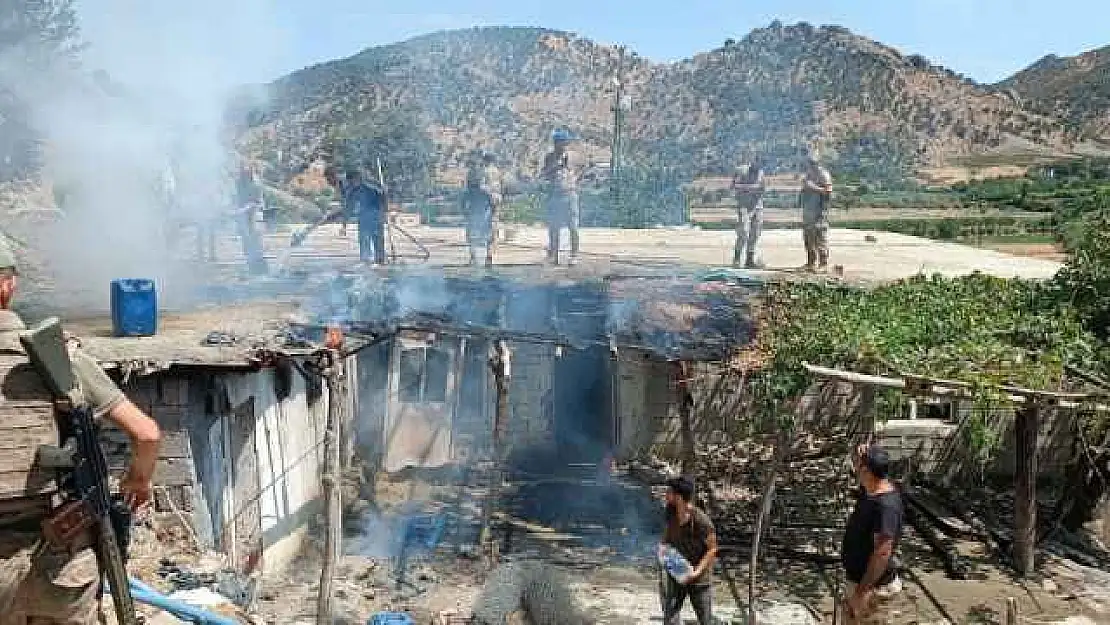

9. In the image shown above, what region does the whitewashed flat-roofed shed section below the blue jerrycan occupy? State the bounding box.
[67,304,356,572]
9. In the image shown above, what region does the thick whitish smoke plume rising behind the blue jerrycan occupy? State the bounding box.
[0,0,282,311]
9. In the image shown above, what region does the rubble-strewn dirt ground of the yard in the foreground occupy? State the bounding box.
[234,470,1110,625]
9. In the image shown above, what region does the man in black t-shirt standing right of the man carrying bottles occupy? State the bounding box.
[840,445,904,623]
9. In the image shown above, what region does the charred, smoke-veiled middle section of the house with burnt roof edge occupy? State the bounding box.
[308,274,756,472]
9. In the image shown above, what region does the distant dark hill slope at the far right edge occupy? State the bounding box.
[997,46,1110,142]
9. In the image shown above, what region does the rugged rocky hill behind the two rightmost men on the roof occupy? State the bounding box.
[640,24,1083,164]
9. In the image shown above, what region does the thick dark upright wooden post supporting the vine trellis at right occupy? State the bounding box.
[1013,402,1040,576]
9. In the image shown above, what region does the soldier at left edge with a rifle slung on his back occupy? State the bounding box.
[0,242,161,625]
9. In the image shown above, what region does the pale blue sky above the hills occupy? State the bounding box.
[78,0,1110,82]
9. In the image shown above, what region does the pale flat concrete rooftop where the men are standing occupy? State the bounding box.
[254,225,1060,283]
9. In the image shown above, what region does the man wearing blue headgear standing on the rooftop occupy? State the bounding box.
[539,128,581,265]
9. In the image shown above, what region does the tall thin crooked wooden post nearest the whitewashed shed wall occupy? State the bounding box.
[316,350,345,625]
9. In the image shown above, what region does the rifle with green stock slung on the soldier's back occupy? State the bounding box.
[19,317,137,625]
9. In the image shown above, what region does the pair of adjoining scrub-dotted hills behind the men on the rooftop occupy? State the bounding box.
[243,22,1092,193]
